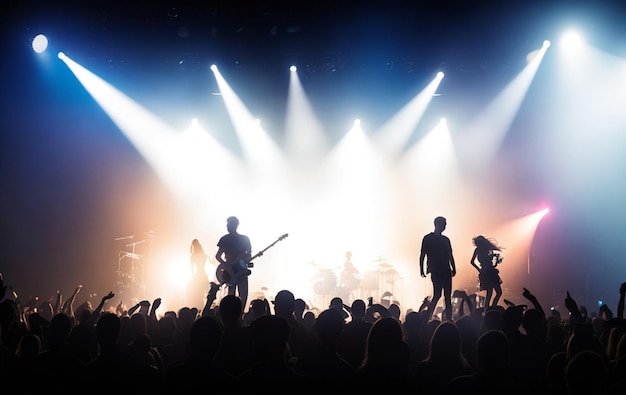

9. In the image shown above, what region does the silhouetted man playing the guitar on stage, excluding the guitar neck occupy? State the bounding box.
[215,217,252,306]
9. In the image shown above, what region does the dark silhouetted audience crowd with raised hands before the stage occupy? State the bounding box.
[0,277,626,395]
